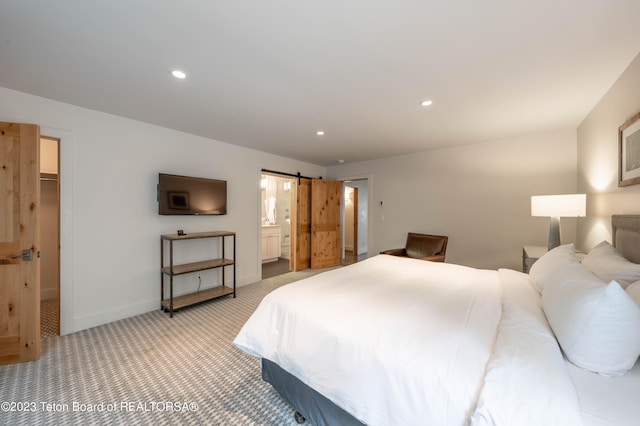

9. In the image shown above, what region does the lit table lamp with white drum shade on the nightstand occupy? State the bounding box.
[531,194,587,250]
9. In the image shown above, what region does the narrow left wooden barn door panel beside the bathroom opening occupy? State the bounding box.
[292,178,311,271]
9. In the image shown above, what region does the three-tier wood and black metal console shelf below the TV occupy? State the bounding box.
[160,231,236,317]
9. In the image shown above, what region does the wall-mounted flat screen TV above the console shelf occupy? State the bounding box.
[158,173,227,215]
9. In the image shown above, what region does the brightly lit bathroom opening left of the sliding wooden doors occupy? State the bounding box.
[260,172,296,279]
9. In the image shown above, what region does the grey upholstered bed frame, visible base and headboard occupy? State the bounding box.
[262,215,640,426]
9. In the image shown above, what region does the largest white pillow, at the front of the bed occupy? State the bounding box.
[542,277,640,376]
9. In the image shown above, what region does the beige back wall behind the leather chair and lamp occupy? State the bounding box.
[328,129,577,269]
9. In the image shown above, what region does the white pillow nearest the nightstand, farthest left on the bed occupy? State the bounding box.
[529,244,580,293]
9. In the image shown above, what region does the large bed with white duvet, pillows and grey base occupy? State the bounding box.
[234,216,640,426]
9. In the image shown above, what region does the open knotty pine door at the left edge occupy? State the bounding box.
[0,122,40,364]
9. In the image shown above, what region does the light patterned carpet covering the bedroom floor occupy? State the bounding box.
[0,271,330,425]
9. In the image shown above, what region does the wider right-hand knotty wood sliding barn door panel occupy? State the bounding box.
[311,179,342,269]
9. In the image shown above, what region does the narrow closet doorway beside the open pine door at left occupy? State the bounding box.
[40,136,60,339]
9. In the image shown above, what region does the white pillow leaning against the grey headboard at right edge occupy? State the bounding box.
[582,241,640,288]
